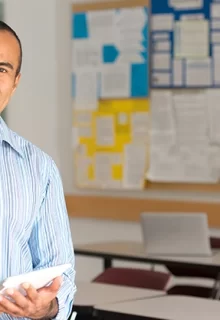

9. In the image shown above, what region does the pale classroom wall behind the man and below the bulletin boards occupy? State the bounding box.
[5,0,220,280]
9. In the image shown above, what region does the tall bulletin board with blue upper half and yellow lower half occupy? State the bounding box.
[72,0,149,189]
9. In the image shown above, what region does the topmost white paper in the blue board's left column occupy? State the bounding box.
[152,14,174,31]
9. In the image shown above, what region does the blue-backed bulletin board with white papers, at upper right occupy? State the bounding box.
[151,0,220,88]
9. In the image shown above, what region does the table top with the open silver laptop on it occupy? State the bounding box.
[75,241,220,268]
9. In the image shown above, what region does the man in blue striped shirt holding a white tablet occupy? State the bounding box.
[0,21,76,320]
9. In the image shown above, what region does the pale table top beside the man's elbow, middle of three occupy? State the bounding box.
[74,282,165,307]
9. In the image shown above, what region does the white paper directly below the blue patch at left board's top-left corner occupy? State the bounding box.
[72,39,101,72]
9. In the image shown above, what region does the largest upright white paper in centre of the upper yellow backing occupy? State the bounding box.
[96,116,115,147]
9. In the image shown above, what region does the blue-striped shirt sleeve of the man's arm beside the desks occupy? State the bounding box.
[29,161,76,320]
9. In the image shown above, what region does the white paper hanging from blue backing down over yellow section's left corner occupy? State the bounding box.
[73,69,98,111]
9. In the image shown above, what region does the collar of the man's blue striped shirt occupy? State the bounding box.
[0,117,24,157]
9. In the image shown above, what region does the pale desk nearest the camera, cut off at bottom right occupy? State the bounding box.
[95,296,220,320]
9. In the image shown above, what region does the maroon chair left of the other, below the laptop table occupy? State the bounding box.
[93,267,170,291]
